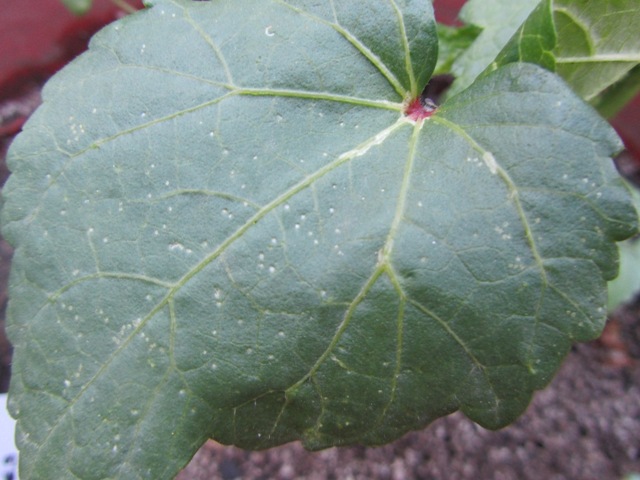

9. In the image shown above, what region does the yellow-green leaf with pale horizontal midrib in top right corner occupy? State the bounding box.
[554,0,640,100]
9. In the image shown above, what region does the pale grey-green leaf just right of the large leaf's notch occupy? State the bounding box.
[447,0,540,96]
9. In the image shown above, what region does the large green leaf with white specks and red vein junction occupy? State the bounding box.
[2,0,636,479]
